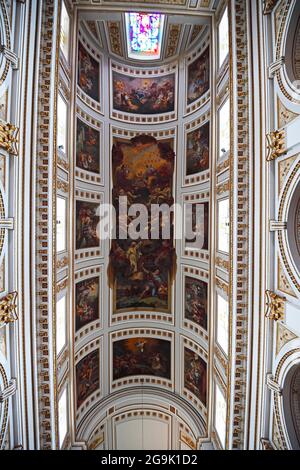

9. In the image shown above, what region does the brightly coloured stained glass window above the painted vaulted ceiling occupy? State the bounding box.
[125,13,164,60]
